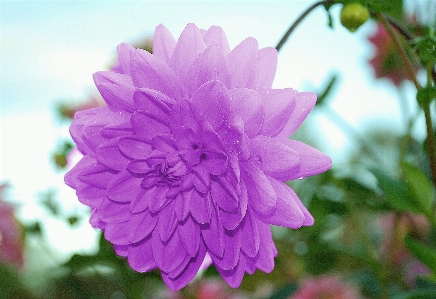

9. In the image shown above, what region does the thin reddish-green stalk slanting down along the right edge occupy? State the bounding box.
[377,13,436,187]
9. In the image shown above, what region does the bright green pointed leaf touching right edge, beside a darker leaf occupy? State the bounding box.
[403,163,434,215]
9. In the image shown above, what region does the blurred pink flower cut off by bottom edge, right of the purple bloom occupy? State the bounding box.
[289,275,361,299]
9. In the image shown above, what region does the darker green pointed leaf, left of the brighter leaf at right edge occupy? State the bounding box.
[371,169,422,213]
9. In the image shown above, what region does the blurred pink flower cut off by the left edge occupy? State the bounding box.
[0,184,24,268]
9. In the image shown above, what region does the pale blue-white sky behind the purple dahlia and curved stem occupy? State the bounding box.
[0,0,420,260]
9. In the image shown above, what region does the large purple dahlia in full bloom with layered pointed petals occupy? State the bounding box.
[65,24,331,290]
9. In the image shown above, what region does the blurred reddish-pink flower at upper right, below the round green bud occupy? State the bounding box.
[368,24,418,86]
